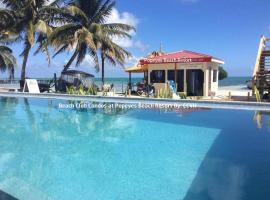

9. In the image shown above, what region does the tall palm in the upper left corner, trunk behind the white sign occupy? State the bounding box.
[0,0,60,80]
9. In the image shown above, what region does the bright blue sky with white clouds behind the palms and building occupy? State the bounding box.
[0,0,270,77]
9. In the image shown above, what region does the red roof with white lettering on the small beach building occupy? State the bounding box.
[140,50,223,64]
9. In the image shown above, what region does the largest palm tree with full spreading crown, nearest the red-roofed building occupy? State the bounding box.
[50,0,134,82]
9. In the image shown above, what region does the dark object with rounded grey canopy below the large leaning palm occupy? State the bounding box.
[56,70,95,92]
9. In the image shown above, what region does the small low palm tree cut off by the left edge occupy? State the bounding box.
[0,39,16,80]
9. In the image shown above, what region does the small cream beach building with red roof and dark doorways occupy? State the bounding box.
[125,50,224,96]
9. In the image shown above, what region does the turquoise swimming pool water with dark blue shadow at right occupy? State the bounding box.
[0,98,270,200]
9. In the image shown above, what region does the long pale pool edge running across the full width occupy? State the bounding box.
[0,92,270,111]
